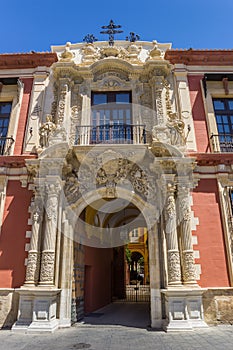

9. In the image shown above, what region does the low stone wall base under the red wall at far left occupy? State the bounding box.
[0,290,19,329]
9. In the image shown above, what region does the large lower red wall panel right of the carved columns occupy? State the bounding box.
[192,179,230,287]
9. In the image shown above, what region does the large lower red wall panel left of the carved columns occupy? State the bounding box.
[0,181,31,288]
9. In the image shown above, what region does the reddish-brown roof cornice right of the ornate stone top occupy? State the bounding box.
[165,49,233,66]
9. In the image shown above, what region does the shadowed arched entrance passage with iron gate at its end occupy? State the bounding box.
[70,195,161,327]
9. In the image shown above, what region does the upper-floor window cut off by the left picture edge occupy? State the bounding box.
[0,102,12,155]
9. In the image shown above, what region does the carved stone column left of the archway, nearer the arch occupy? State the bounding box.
[39,182,61,285]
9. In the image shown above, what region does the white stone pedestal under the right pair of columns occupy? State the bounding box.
[162,288,208,332]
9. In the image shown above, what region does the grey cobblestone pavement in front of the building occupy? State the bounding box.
[0,324,233,350]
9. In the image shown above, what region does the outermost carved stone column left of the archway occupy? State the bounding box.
[25,192,43,285]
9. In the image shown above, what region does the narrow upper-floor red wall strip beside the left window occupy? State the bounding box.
[14,78,33,155]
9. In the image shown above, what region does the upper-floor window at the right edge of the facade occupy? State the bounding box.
[213,98,233,152]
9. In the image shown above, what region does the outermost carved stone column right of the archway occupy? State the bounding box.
[179,187,197,284]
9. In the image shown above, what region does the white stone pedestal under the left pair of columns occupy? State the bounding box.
[12,287,60,333]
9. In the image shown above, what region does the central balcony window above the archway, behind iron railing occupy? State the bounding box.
[91,91,133,143]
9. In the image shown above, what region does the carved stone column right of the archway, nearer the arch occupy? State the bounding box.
[165,185,181,285]
